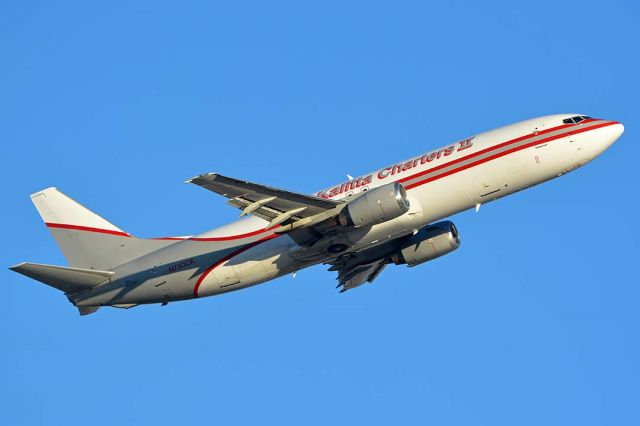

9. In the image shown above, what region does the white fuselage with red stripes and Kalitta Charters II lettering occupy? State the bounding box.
[72,114,623,305]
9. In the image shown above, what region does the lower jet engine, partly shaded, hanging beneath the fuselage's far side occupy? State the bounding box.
[391,220,460,266]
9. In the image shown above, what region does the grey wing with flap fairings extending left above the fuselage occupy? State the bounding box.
[187,173,346,244]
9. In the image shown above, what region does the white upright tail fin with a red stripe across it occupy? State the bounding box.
[31,188,174,272]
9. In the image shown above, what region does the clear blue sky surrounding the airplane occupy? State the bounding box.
[0,0,640,426]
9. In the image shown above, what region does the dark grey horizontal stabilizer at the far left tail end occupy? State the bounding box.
[10,262,113,294]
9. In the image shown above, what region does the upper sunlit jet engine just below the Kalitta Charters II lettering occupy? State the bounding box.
[338,182,409,228]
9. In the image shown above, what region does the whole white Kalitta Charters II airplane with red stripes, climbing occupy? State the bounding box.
[10,114,624,315]
